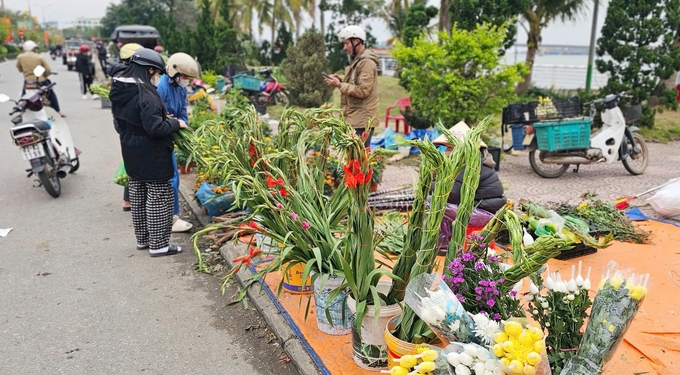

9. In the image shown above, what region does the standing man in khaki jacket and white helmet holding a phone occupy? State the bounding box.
[324,25,378,147]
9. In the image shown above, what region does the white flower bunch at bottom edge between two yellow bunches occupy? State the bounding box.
[441,342,503,375]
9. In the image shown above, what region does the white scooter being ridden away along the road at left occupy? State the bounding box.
[0,66,80,198]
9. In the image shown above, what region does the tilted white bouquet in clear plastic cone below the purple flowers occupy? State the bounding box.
[404,273,480,343]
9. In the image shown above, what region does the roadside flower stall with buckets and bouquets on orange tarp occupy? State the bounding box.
[177,103,680,375]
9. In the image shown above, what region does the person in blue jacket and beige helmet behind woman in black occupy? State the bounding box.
[156,52,198,232]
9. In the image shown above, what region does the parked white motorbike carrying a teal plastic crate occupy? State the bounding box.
[525,92,649,178]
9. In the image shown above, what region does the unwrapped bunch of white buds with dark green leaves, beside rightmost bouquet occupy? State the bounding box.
[526,262,592,374]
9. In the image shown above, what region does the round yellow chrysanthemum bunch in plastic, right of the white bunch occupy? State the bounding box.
[491,318,551,375]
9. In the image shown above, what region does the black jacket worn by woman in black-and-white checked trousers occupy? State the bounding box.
[109,77,179,181]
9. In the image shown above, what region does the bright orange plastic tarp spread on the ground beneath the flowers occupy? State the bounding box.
[254,221,680,375]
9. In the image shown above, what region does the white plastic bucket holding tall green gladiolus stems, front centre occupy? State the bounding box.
[347,280,401,371]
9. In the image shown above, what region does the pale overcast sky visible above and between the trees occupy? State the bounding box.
[4,0,608,45]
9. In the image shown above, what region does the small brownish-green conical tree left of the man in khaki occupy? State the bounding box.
[281,29,333,107]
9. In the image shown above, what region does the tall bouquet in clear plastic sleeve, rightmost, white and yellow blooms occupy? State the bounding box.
[561,261,649,375]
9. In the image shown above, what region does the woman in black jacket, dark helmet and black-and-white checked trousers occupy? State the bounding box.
[109,48,187,257]
